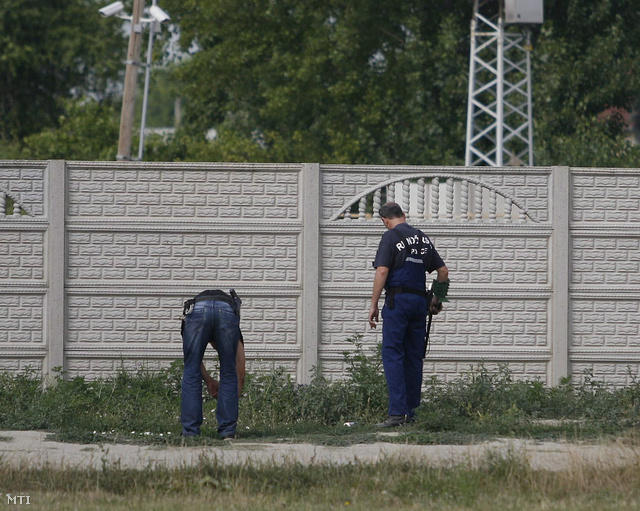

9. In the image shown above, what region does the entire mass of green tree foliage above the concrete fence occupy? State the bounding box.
[0,0,640,167]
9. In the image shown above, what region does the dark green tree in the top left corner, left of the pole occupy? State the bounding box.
[0,0,126,141]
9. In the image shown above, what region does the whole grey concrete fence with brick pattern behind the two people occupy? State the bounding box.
[0,160,640,385]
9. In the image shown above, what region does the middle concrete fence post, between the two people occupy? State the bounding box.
[299,163,320,383]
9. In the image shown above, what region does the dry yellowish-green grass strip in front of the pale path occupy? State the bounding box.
[0,453,640,511]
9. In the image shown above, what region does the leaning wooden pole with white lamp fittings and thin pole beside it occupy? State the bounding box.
[98,0,171,160]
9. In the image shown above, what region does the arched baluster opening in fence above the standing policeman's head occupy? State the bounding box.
[331,174,537,223]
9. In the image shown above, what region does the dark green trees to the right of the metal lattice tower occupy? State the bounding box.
[534,0,640,167]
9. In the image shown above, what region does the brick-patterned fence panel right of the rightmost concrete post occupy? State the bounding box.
[569,168,640,385]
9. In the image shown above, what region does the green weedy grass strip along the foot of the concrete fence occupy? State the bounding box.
[0,337,640,446]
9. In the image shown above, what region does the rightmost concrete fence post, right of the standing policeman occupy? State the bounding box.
[550,167,571,385]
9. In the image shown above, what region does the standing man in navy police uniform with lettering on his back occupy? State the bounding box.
[369,202,449,428]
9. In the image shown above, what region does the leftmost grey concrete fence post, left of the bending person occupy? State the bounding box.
[43,160,67,376]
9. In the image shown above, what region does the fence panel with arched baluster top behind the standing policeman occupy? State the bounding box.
[319,166,566,383]
